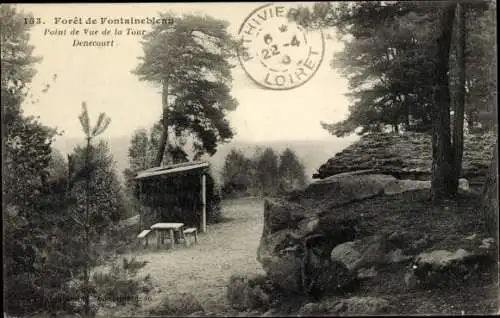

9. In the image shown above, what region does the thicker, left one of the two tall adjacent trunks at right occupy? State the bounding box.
[431,3,456,201]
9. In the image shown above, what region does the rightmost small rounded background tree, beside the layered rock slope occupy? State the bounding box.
[278,148,306,192]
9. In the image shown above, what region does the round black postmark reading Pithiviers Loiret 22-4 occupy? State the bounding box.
[238,4,325,90]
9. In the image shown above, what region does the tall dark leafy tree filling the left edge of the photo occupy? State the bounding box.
[0,5,66,315]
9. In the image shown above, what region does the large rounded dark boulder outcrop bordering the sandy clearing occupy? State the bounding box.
[257,171,446,294]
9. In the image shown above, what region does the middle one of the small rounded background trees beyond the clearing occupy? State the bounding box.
[256,147,278,195]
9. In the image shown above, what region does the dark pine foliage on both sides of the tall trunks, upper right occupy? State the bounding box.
[291,1,496,137]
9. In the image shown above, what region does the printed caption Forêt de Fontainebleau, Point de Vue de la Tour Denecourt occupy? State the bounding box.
[29,17,174,48]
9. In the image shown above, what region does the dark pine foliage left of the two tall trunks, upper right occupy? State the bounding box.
[292,2,433,137]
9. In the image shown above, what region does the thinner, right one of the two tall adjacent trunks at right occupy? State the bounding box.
[451,3,466,194]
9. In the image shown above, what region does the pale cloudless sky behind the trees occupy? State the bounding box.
[17,2,348,142]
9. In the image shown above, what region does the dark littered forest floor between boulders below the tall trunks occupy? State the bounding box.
[281,190,500,315]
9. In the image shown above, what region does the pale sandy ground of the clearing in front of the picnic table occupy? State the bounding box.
[102,198,264,316]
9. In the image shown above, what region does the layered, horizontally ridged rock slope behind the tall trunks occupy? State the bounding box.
[313,132,497,183]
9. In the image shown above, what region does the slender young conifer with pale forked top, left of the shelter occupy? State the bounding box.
[68,102,119,316]
